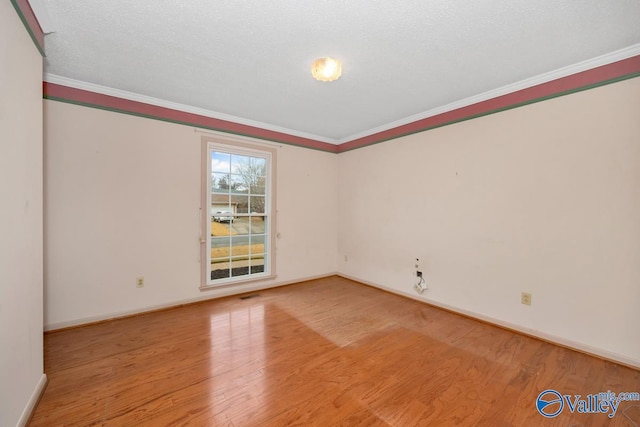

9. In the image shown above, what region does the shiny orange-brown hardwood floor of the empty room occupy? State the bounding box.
[30,277,640,427]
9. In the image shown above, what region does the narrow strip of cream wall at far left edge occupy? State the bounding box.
[0,2,46,426]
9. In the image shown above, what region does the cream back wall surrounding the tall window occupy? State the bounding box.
[45,101,337,329]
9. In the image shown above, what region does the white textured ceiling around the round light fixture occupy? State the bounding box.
[31,0,640,143]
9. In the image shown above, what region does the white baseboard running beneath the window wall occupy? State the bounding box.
[44,272,337,332]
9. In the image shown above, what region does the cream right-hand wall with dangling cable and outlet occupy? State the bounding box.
[338,78,640,366]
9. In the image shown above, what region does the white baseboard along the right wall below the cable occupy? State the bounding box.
[337,273,640,369]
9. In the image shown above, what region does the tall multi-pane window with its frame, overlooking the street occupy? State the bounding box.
[201,136,275,289]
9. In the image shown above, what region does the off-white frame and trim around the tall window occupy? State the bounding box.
[200,135,277,290]
